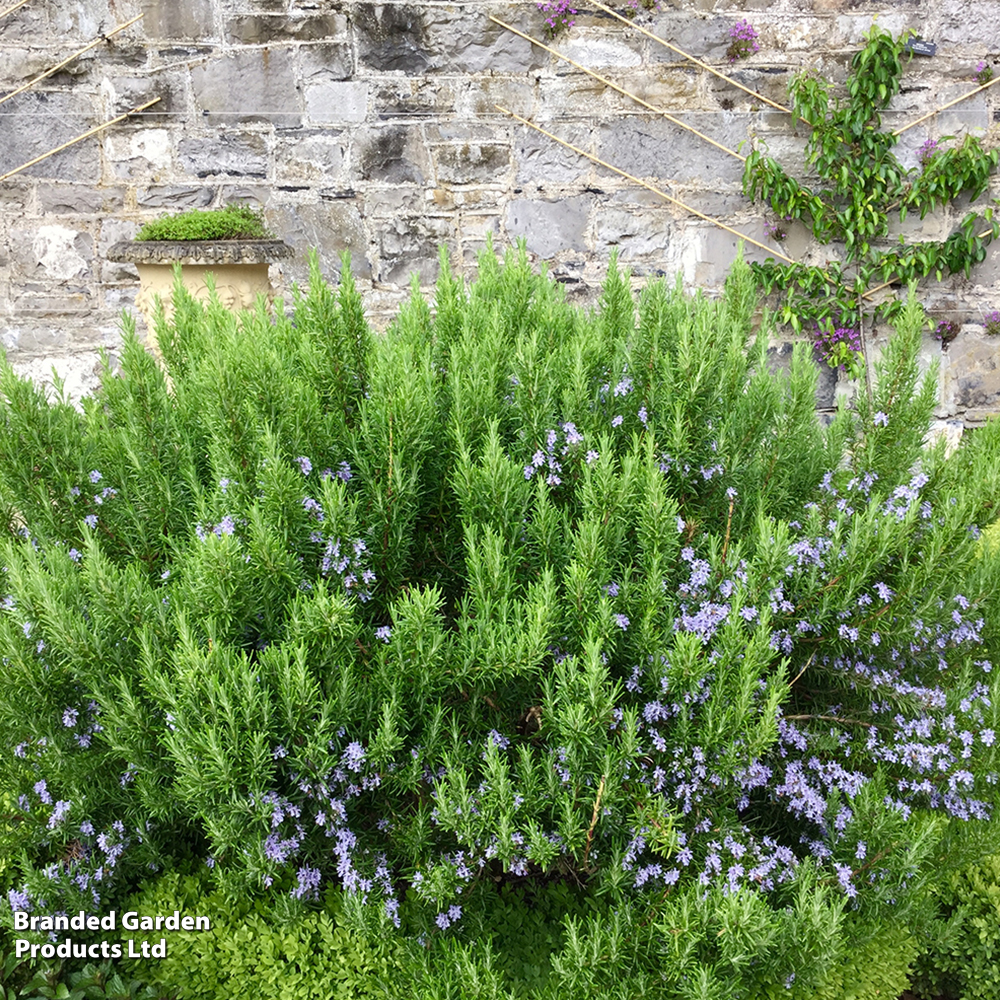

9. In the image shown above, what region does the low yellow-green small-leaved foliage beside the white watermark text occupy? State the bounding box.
[122,868,398,1000]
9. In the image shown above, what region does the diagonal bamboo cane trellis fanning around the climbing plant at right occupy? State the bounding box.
[490,12,1000,316]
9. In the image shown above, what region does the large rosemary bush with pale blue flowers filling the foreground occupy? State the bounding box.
[0,244,1000,1000]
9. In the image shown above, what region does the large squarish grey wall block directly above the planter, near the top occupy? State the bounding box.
[191,48,301,126]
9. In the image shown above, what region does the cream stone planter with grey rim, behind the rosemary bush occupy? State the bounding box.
[108,240,292,330]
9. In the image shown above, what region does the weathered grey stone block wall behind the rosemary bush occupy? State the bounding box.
[0,0,1000,423]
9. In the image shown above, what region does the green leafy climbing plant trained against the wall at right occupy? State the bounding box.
[743,25,1000,374]
